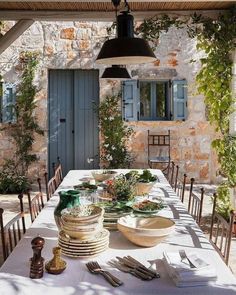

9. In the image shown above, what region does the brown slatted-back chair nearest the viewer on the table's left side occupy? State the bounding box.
[0,194,25,261]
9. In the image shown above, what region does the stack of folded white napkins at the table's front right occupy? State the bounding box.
[163,252,217,287]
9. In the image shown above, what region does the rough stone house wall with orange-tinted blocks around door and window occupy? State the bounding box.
[0,22,217,182]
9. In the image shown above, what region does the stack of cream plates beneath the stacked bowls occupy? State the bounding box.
[58,229,110,258]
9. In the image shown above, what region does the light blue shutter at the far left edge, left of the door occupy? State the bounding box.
[2,82,16,123]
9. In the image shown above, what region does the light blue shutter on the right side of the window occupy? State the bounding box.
[172,80,187,120]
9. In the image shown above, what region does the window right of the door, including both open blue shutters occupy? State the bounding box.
[122,80,187,121]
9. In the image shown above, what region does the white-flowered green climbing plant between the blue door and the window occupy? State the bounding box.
[98,95,133,169]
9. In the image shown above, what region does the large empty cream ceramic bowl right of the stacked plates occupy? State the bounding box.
[117,215,175,247]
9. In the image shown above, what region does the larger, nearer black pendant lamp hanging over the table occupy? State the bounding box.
[96,0,156,65]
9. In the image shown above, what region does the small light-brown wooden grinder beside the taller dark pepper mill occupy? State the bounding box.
[45,247,66,275]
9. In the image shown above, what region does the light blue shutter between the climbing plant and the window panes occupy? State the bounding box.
[122,80,139,121]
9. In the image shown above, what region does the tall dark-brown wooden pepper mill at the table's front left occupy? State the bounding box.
[30,237,45,279]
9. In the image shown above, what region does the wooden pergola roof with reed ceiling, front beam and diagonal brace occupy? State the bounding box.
[0,0,236,54]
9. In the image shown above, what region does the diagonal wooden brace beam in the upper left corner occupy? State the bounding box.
[0,19,34,54]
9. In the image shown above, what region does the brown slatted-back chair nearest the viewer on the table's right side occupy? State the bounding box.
[210,194,236,265]
